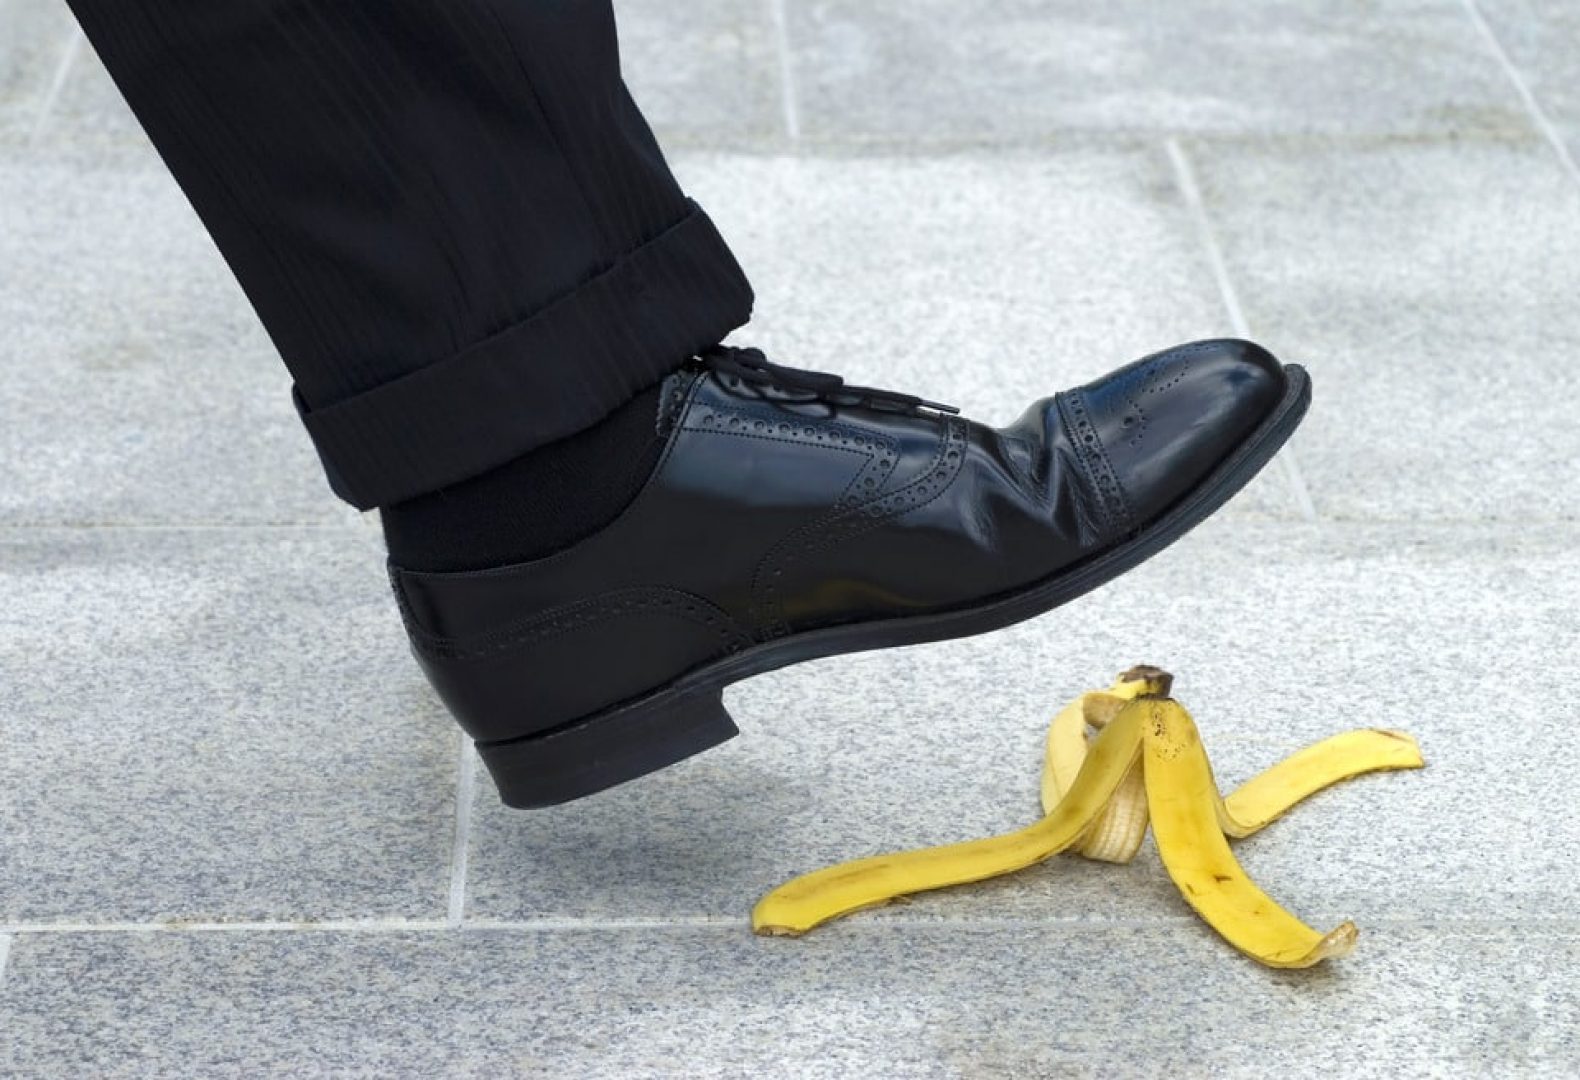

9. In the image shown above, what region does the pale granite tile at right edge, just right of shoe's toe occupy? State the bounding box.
[1191,144,1580,523]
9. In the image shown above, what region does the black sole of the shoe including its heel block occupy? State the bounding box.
[477,365,1311,808]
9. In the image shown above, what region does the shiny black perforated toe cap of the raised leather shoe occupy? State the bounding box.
[1079,339,1285,527]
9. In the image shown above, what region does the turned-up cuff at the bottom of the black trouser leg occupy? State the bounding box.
[292,204,752,510]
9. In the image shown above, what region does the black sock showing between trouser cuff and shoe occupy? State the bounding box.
[388,384,664,572]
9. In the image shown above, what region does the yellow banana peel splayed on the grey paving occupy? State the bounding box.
[752,666,1424,968]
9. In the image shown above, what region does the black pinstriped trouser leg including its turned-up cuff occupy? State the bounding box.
[70,0,752,508]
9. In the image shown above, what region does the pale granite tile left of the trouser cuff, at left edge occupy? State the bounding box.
[0,164,357,524]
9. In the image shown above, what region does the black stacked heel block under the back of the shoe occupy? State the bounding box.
[477,688,739,810]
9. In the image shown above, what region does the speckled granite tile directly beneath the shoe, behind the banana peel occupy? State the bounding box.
[469,518,1580,924]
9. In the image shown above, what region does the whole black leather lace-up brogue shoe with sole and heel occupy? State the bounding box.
[390,341,1310,807]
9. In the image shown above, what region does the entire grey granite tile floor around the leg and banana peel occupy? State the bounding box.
[0,0,1580,1077]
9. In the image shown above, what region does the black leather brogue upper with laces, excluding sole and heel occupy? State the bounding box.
[392,341,1283,741]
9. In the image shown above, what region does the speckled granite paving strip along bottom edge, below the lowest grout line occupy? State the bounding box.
[0,924,1580,1080]
